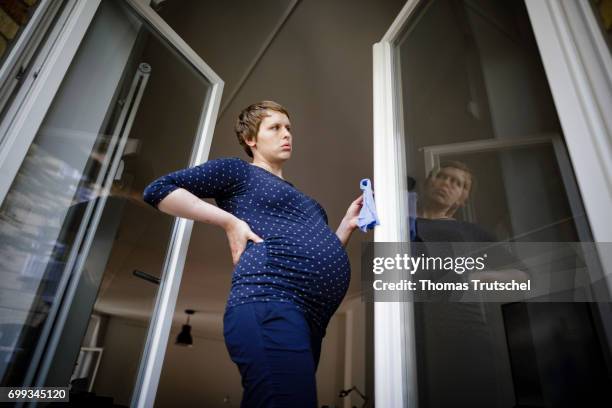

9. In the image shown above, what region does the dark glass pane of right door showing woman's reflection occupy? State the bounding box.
[396,0,611,407]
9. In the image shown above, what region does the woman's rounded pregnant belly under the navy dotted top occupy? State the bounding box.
[228,222,350,325]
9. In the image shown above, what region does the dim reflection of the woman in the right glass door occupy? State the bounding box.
[414,161,527,407]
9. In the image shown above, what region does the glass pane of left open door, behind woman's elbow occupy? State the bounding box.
[0,0,210,406]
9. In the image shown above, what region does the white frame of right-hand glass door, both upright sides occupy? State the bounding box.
[373,0,612,408]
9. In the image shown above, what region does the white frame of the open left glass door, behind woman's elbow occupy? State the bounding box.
[0,0,224,407]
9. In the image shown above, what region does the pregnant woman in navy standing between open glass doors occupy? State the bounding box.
[144,101,363,408]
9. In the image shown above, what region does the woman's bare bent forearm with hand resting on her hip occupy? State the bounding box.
[157,188,263,265]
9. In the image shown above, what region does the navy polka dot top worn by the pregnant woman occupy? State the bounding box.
[143,158,350,329]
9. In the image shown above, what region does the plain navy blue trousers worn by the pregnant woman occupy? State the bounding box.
[223,301,325,408]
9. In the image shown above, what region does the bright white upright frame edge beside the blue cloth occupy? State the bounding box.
[373,0,419,408]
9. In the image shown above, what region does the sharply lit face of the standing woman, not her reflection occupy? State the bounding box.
[247,110,293,162]
